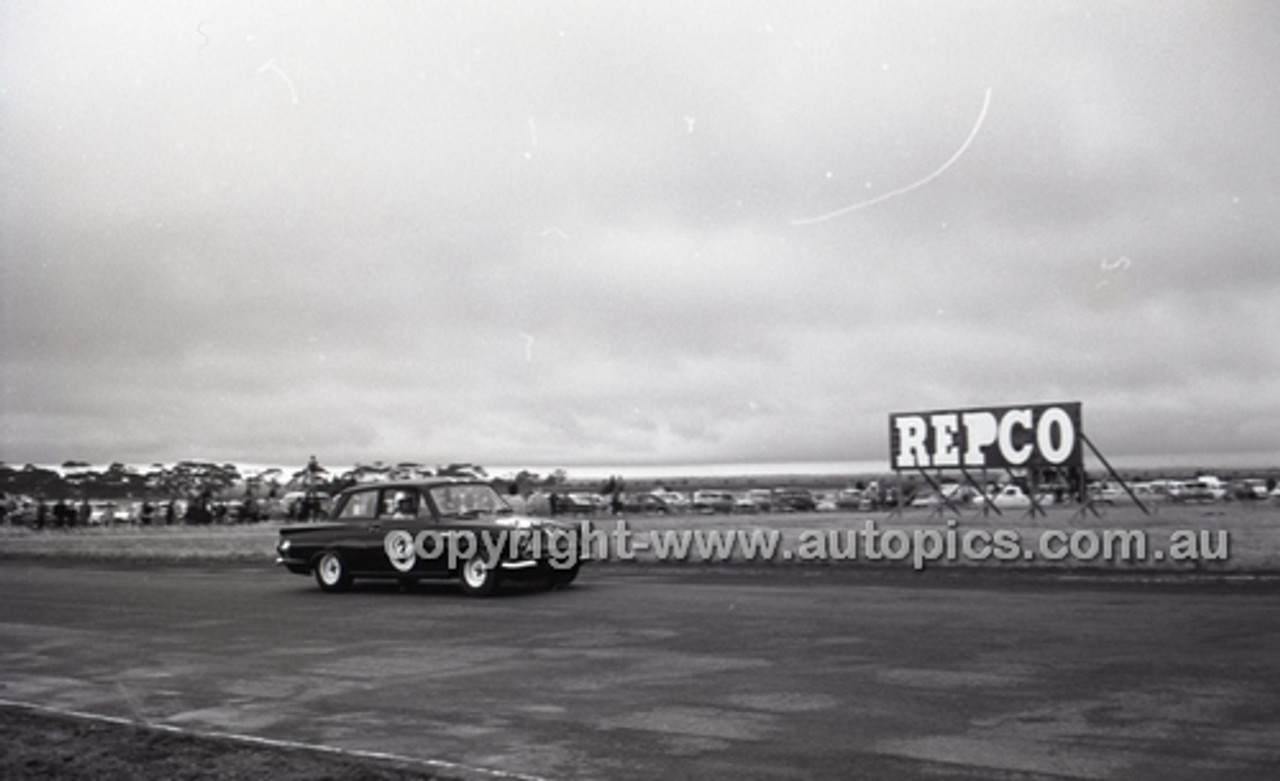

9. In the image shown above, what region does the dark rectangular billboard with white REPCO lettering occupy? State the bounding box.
[888,402,1084,469]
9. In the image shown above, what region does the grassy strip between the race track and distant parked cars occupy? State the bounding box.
[0,502,1280,574]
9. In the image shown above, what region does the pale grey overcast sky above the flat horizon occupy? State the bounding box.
[0,0,1280,466]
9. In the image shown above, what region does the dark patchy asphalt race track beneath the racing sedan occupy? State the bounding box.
[0,561,1280,781]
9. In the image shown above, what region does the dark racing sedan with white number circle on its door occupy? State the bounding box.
[275,479,581,597]
